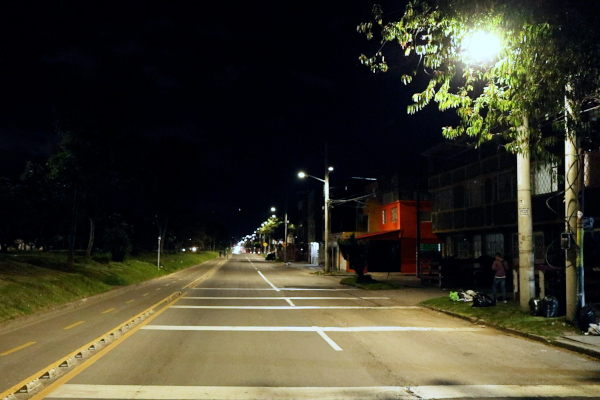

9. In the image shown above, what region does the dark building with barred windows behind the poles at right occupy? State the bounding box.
[424,141,600,304]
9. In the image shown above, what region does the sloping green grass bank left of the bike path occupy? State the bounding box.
[0,251,218,322]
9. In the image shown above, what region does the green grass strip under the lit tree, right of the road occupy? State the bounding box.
[420,297,581,341]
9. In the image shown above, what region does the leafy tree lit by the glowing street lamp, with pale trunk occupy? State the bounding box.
[358,0,600,318]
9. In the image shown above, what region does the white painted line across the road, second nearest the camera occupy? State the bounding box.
[141,325,483,332]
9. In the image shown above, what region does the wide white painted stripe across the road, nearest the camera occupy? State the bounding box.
[46,384,600,400]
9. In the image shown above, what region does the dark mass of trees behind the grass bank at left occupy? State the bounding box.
[0,120,228,266]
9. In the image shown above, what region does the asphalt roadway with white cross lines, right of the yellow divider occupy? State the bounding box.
[0,255,600,399]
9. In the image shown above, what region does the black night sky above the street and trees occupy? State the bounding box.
[0,0,452,238]
